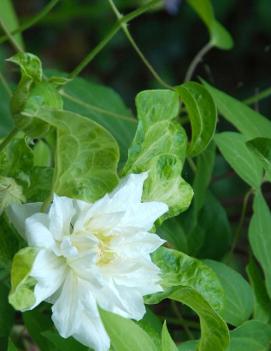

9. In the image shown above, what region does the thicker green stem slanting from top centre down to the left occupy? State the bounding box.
[69,0,161,79]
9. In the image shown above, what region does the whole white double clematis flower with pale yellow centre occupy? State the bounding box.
[9,173,168,351]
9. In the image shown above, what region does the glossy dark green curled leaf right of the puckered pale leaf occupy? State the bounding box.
[176,82,217,156]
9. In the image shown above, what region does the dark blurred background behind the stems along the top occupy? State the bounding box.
[7,0,271,114]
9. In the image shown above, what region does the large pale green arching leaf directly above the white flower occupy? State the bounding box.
[33,110,119,202]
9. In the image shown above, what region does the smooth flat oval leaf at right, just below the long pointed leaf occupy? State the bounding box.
[215,132,263,189]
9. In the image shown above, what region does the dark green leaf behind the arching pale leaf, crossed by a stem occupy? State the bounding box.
[61,78,137,162]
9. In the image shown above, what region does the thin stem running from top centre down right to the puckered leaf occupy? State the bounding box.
[108,0,173,89]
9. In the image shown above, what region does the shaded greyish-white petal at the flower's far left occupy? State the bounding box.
[6,202,42,238]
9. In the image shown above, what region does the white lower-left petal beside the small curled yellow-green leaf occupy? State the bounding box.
[30,250,66,308]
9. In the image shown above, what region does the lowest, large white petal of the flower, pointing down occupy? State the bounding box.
[52,273,110,351]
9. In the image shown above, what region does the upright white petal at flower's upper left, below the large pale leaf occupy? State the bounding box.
[49,195,75,240]
